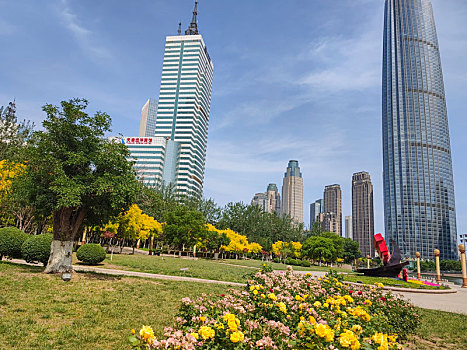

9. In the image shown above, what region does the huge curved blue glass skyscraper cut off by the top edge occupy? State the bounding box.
[383,0,457,259]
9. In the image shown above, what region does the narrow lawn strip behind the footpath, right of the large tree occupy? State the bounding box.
[93,254,255,283]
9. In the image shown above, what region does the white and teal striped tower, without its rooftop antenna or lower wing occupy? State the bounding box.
[155,35,214,196]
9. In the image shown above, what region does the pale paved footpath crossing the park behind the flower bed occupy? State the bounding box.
[9,259,467,315]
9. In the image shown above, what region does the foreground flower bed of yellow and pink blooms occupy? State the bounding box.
[129,271,420,350]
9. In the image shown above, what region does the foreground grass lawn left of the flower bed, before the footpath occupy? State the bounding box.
[0,262,229,350]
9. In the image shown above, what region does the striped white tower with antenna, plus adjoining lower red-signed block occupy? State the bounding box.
[128,2,214,196]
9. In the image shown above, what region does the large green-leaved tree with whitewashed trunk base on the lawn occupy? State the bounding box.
[18,99,137,273]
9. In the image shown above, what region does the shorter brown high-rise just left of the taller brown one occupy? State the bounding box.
[321,185,342,236]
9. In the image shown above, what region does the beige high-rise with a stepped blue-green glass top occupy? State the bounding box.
[281,160,303,224]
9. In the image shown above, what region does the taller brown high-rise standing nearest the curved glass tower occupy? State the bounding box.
[352,171,375,256]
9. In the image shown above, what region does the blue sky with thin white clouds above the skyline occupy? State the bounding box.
[0,0,467,237]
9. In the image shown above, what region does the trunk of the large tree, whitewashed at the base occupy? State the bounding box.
[44,208,86,273]
